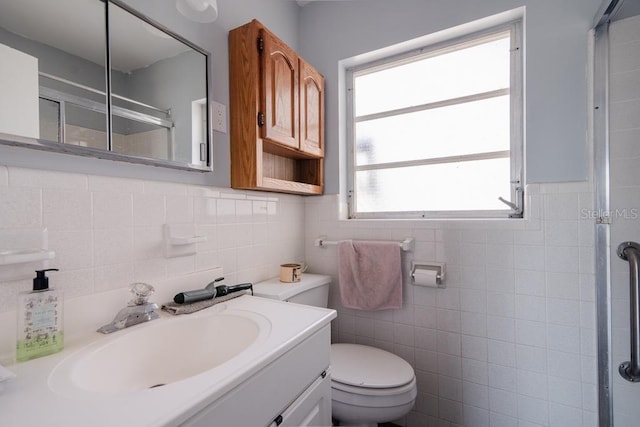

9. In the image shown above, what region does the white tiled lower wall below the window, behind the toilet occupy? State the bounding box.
[305,183,597,427]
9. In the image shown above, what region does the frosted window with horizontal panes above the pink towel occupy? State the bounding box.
[347,22,523,218]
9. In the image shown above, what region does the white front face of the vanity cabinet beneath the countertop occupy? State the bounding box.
[179,325,331,427]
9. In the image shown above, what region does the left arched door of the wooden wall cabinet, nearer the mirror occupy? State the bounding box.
[261,32,299,148]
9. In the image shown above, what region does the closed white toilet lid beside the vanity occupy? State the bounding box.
[331,344,414,388]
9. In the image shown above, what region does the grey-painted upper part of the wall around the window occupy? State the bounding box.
[300,0,600,194]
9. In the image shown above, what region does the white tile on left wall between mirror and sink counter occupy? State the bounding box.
[0,166,306,312]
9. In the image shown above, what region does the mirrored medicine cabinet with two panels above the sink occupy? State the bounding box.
[0,0,212,171]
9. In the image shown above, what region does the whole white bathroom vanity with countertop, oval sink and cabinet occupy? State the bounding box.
[0,270,336,427]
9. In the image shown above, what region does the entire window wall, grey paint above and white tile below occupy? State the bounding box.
[300,0,599,427]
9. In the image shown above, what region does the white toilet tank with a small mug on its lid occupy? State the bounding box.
[253,273,331,308]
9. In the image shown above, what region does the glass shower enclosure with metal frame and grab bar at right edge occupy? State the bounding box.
[593,0,640,427]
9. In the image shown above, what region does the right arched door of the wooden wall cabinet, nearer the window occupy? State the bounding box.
[300,58,324,157]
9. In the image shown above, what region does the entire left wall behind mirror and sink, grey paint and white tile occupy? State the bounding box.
[0,0,304,324]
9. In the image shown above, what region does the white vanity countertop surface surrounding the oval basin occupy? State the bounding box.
[0,295,336,427]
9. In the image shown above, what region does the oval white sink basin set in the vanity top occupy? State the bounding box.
[50,311,271,394]
